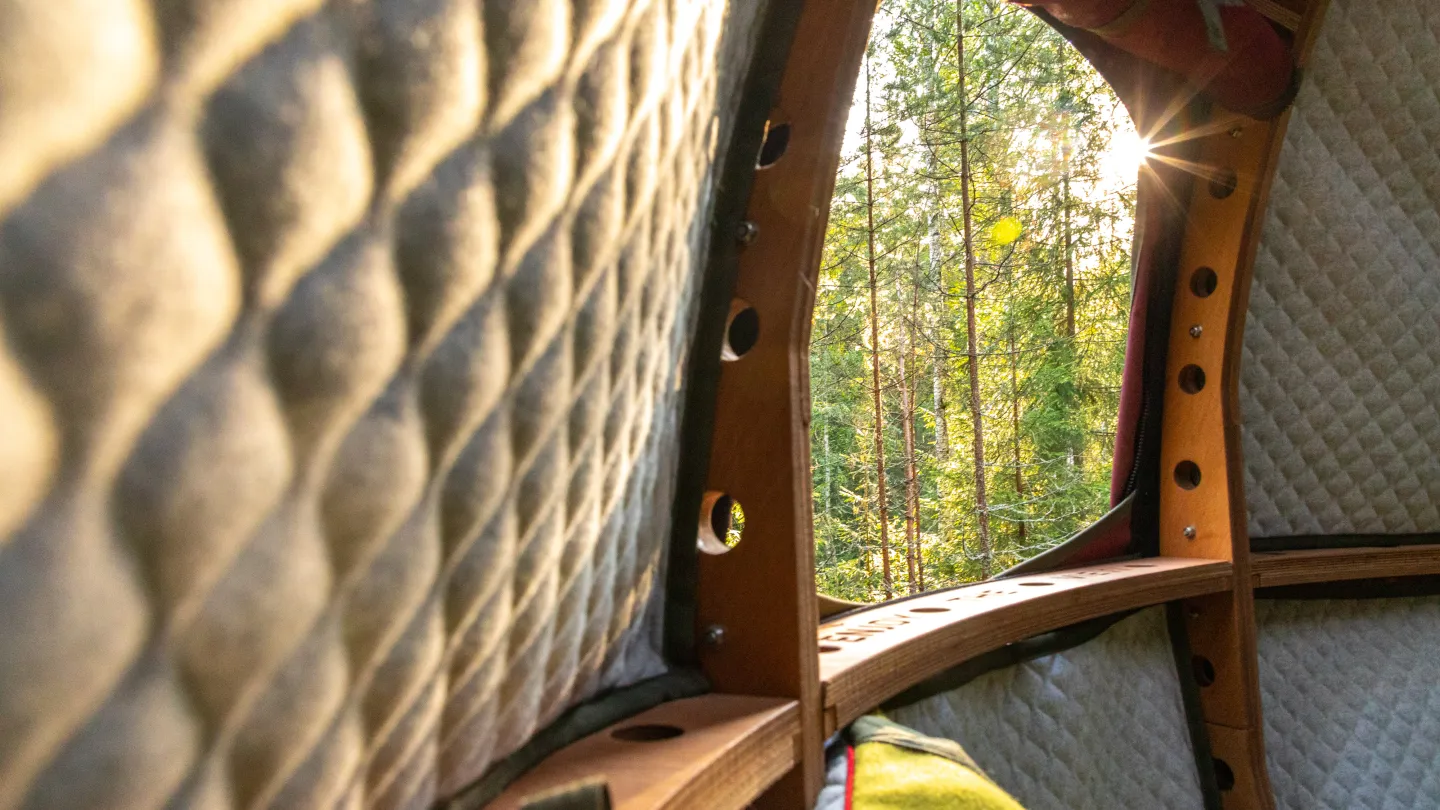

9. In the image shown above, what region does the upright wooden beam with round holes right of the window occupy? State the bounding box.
[1159,0,1323,810]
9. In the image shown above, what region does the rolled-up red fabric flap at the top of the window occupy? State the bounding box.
[1025,0,1295,117]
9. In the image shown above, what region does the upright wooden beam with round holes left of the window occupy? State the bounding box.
[696,0,876,809]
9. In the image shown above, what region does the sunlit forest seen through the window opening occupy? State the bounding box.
[811,0,1145,601]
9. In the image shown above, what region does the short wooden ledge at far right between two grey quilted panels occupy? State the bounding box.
[1250,545,1440,588]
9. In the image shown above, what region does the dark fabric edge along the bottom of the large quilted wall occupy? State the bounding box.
[436,670,710,810]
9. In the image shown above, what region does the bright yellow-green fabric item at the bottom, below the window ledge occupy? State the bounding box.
[848,715,1024,810]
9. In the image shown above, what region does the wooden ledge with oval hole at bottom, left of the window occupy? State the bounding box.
[490,695,801,810]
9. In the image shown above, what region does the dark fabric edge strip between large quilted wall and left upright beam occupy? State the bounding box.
[664,1,804,666]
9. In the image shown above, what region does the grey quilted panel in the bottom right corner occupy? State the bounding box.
[1256,597,1440,810]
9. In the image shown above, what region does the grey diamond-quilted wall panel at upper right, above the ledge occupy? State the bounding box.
[1240,0,1440,536]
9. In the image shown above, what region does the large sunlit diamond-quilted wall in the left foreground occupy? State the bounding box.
[0,0,759,809]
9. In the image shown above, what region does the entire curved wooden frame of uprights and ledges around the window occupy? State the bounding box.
[497,0,1440,809]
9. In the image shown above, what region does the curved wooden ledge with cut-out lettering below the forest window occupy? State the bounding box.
[819,558,1231,734]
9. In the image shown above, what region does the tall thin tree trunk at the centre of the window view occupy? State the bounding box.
[955,4,991,578]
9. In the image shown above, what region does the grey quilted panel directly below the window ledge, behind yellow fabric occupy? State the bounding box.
[888,608,1204,810]
